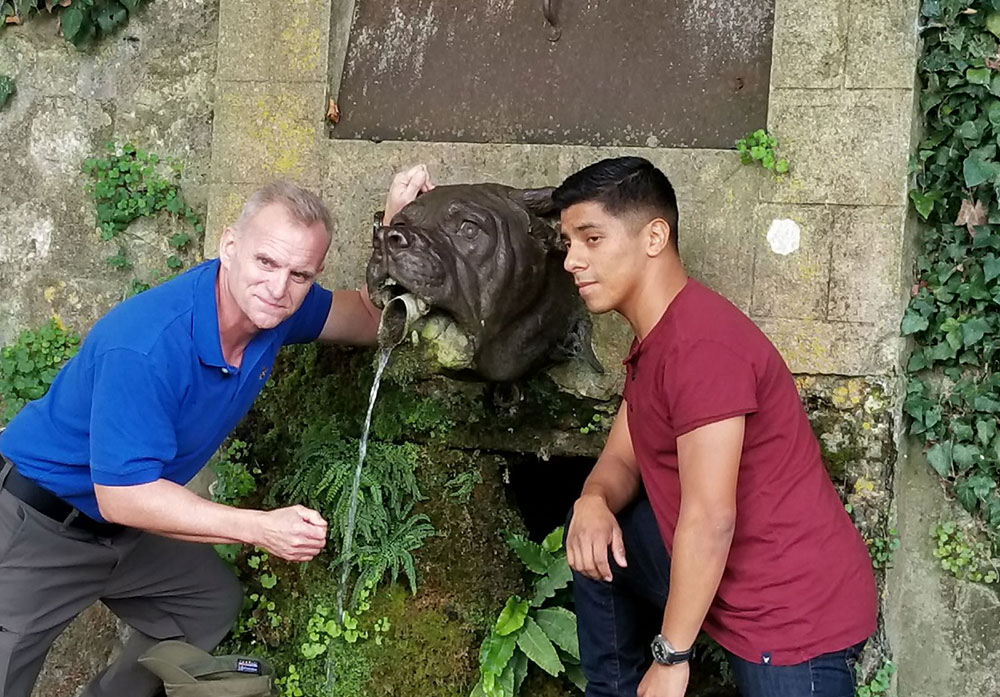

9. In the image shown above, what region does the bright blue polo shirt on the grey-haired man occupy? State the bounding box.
[0,259,333,520]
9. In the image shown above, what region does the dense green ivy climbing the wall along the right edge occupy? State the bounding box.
[902,0,1000,551]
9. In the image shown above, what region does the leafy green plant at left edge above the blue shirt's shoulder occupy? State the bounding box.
[0,318,80,424]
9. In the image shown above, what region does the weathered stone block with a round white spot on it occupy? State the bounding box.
[750,204,831,319]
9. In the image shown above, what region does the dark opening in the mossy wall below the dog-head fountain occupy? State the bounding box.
[507,455,595,542]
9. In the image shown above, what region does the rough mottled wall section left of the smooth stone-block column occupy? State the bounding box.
[0,0,218,697]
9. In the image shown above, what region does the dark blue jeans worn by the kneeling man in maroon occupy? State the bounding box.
[566,499,864,697]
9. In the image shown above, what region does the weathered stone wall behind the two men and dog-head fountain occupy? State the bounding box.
[0,0,1000,697]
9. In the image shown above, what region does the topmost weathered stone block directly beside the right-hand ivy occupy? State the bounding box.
[840,0,918,89]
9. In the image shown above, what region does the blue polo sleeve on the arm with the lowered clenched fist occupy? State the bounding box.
[90,349,178,486]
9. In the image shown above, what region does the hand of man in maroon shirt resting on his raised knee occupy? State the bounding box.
[566,494,628,581]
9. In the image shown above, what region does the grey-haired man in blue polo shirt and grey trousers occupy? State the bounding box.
[0,166,432,697]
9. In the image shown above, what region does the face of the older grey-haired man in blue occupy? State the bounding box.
[219,203,330,329]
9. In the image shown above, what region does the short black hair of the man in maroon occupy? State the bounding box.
[552,157,677,251]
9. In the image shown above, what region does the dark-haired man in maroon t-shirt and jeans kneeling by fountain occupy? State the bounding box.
[553,157,876,697]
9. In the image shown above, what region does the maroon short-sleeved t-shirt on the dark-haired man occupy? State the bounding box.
[624,279,876,665]
